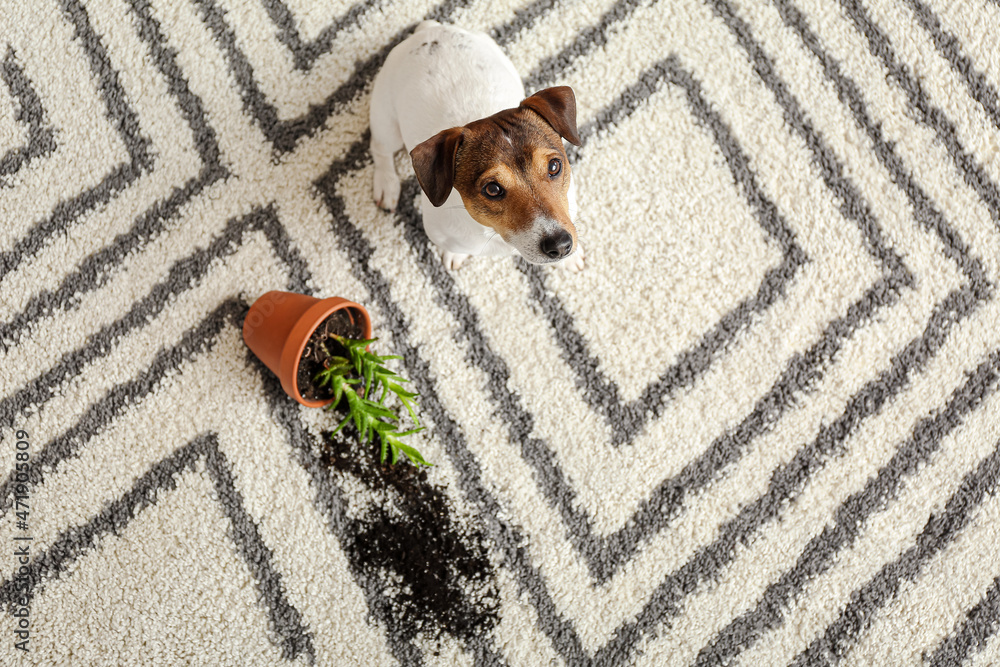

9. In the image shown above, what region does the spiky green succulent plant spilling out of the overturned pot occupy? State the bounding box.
[314,334,431,466]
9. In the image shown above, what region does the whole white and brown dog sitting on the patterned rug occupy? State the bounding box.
[370,21,584,271]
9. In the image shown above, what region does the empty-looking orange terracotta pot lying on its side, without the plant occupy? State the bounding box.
[243,292,372,408]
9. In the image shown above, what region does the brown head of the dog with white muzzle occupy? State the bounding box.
[410,86,580,264]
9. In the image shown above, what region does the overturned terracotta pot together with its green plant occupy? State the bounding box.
[243,292,430,465]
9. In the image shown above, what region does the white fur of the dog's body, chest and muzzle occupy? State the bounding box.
[370,21,584,270]
